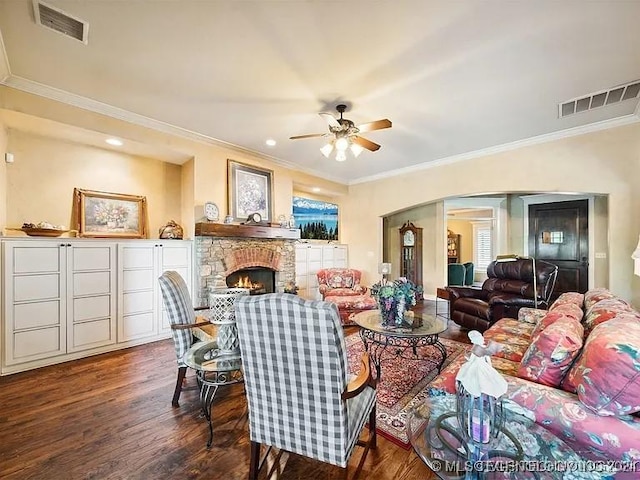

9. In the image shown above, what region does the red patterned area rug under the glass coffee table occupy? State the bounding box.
[346,334,469,449]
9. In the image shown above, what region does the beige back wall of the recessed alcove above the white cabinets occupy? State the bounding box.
[6,130,182,238]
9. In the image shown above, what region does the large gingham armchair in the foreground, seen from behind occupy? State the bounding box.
[235,293,376,480]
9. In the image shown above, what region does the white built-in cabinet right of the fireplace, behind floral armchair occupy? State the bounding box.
[296,243,348,300]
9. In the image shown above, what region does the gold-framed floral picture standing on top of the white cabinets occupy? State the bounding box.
[73,188,147,238]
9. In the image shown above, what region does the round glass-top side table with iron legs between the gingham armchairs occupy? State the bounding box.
[182,341,244,448]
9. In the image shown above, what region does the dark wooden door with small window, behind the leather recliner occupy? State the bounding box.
[529,200,589,301]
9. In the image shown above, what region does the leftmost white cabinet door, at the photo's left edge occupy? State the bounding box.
[2,241,67,365]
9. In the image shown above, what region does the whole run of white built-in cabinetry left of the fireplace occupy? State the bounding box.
[0,238,192,374]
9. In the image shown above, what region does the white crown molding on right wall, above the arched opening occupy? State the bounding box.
[349,113,640,185]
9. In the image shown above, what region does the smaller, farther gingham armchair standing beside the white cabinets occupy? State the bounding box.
[158,270,216,407]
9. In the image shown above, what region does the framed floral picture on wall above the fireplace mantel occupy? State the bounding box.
[227,160,273,222]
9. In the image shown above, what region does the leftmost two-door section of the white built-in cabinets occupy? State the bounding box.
[2,239,116,367]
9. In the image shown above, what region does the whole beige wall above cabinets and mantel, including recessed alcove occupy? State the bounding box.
[0,87,348,237]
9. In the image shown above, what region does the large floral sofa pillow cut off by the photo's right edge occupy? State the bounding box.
[572,313,640,416]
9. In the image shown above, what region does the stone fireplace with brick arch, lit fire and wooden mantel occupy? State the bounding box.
[193,224,299,306]
